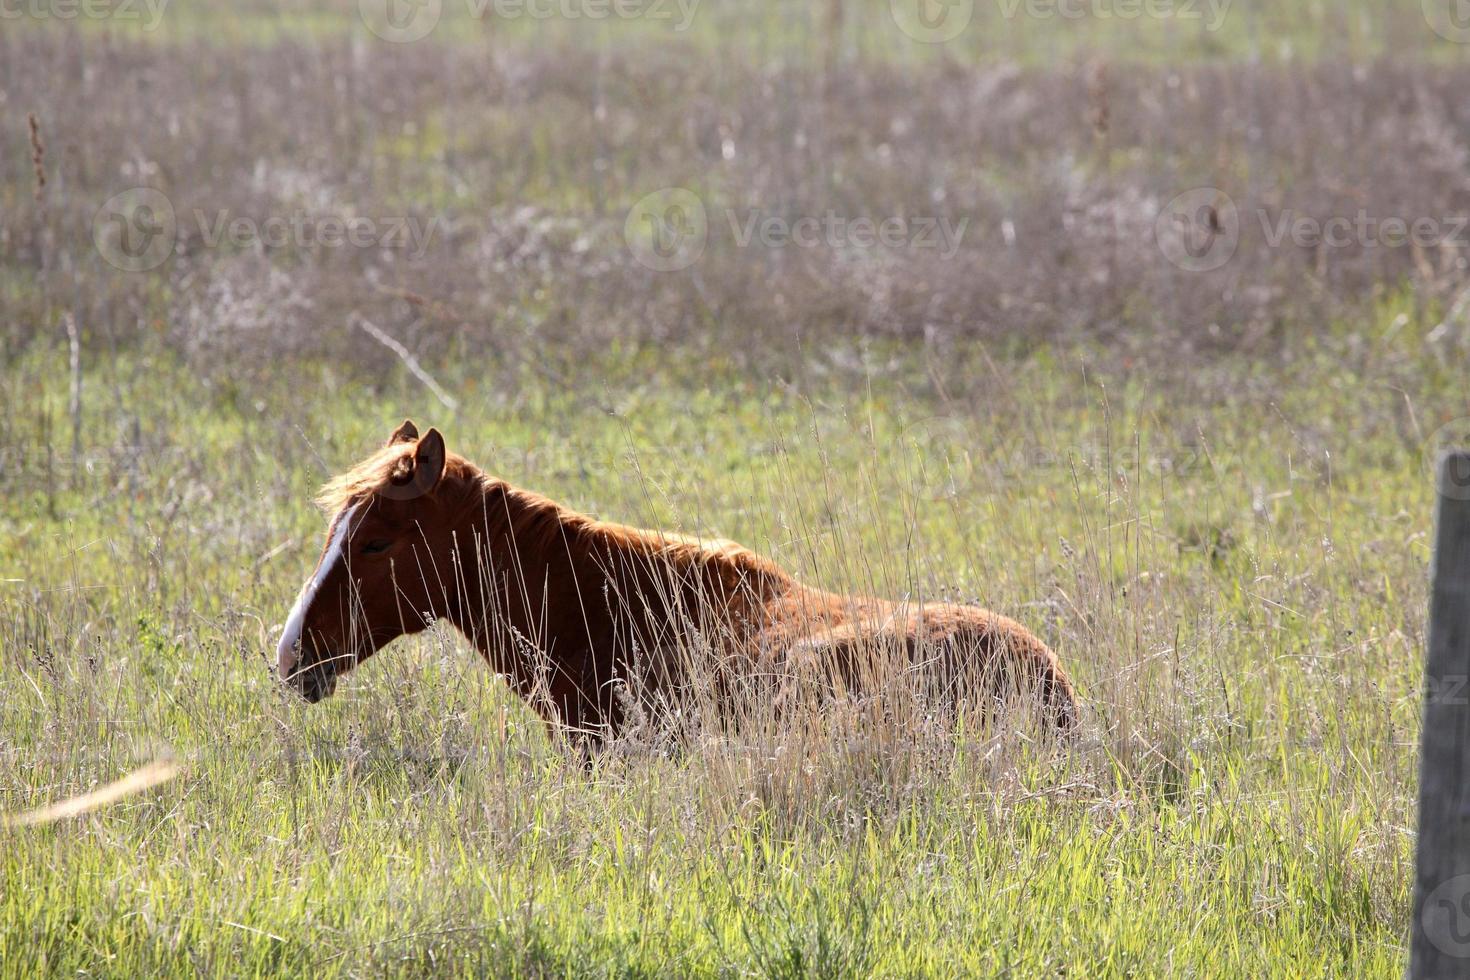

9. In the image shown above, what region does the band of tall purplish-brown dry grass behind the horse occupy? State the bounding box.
[0,31,1470,372]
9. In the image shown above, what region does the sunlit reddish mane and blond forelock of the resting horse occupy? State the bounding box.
[316,442,794,585]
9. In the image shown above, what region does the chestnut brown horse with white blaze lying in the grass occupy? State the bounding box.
[276,422,1078,745]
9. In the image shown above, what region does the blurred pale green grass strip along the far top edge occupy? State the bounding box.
[7,0,1466,66]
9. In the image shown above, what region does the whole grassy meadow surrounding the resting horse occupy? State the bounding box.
[0,3,1470,977]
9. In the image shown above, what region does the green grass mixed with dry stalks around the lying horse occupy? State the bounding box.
[0,309,1446,977]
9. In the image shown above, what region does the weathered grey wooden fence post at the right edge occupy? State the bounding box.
[1408,450,1470,980]
